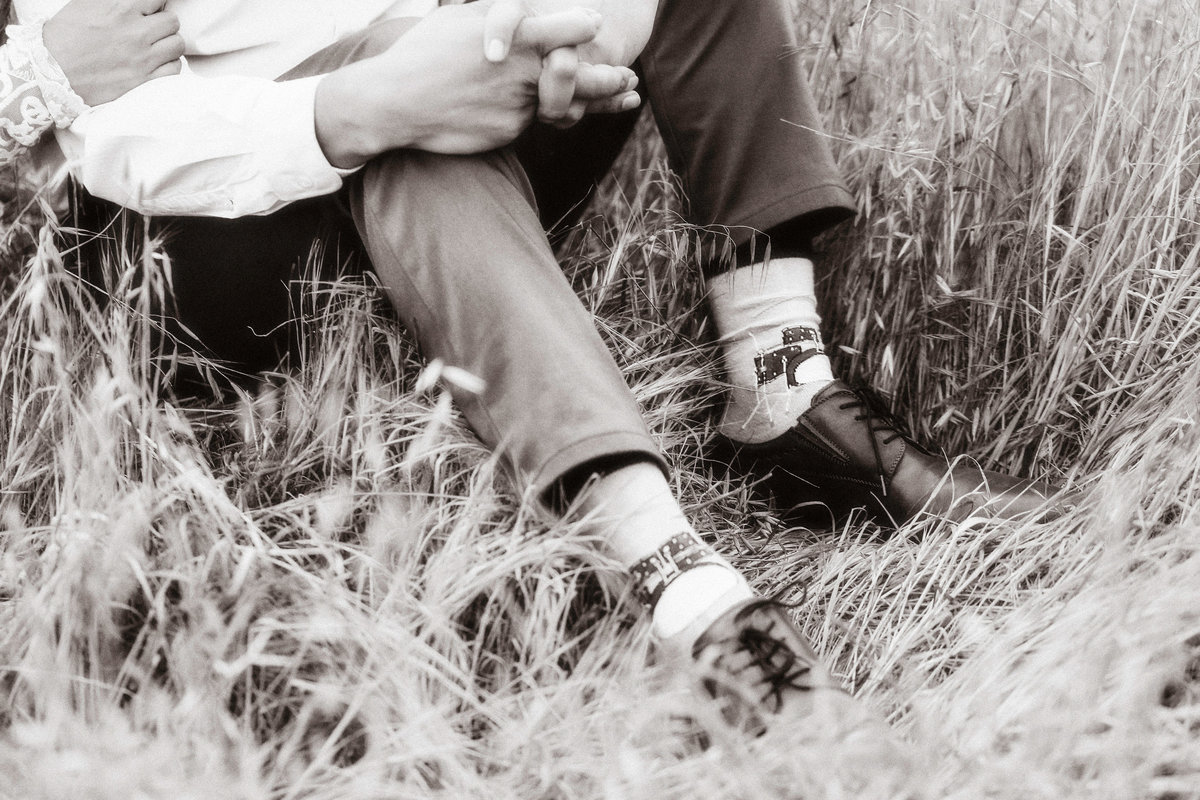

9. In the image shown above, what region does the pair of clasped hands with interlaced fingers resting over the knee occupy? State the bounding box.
[316,0,656,168]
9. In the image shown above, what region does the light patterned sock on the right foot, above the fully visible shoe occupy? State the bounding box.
[708,258,833,443]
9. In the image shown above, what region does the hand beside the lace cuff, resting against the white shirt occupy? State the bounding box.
[42,0,184,106]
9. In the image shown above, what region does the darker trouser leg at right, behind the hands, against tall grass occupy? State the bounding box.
[640,0,854,243]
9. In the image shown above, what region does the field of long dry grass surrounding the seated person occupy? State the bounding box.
[0,0,1200,800]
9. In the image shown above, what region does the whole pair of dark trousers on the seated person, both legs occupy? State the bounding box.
[72,0,852,492]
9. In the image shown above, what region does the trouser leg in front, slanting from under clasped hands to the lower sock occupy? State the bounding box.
[352,150,662,492]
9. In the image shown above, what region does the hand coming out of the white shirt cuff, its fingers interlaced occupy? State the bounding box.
[316,2,631,167]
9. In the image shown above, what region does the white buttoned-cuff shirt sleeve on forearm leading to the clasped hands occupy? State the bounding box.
[58,66,353,217]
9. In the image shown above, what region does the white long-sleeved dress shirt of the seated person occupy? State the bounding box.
[14,0,438,217]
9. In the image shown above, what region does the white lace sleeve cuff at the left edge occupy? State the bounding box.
[0,25,88,163]
